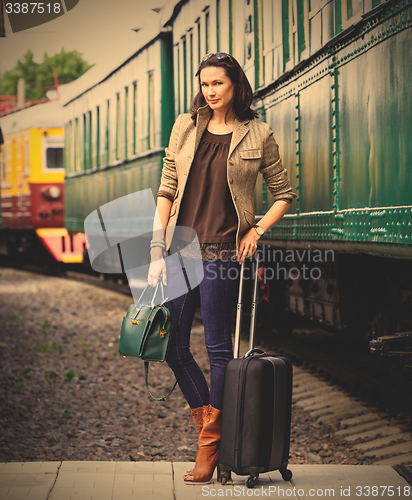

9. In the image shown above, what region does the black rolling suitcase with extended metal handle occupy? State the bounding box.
[219,256,292,488]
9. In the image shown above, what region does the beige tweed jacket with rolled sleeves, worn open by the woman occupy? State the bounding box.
[159,106,296,248]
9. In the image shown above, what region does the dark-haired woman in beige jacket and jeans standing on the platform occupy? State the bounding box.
[148,52,296,484]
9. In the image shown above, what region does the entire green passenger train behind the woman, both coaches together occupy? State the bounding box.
[64,0,412,359]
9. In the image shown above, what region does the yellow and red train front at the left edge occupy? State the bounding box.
[0,102,84,263]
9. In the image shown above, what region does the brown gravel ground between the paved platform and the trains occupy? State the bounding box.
[0,268,368,464]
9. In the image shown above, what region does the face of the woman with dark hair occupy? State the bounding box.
[200,66,235,114]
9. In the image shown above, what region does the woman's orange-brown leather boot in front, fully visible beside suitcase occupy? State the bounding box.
[183,405,222,484]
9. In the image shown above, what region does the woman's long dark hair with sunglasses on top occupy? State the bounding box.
[192,52,258,122]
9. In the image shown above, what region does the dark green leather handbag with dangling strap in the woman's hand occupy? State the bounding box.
[119,281,177,401]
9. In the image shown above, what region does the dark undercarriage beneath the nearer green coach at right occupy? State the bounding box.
[260,246,412,366]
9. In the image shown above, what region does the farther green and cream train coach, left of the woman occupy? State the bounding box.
[61,27,174,232]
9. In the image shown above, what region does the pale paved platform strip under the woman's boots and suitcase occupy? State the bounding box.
[0,462,412,500]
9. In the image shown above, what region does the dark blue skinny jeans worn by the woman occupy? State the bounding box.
[166,260,240,410]
